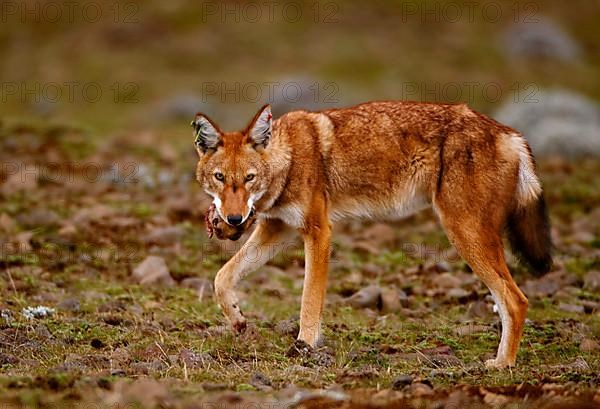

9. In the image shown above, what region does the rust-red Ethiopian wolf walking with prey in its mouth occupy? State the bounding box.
[192,101,552,368]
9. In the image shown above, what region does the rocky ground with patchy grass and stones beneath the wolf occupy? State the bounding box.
[0,125,600,408]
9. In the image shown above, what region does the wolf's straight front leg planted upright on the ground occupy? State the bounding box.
[298,198,331,347]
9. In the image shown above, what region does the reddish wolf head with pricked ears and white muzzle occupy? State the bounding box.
[192,105,273,226]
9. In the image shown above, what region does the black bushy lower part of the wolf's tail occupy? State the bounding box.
[506,194,552,275]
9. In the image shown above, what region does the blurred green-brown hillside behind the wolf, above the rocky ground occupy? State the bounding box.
[0,0,600,135]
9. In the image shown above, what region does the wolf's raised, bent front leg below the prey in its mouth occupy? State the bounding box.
[215,219,294,332]
